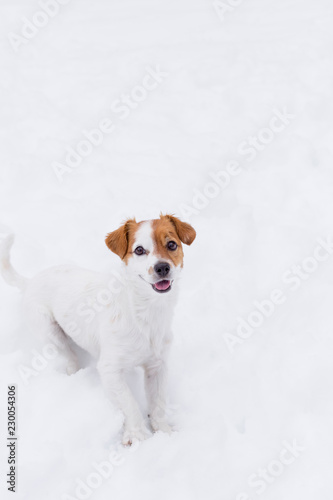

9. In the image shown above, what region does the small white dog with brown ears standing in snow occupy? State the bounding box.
[0,215,196,445]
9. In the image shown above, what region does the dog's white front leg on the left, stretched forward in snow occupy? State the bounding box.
[98,362,149,445]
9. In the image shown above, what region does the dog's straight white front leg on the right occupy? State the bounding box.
[144,360,172,434]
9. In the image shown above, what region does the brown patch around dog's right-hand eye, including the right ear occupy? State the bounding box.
[152,215,196,267]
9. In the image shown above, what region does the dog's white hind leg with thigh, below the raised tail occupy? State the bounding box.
[28,304,79,375]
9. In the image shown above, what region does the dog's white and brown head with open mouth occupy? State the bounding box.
[105,215,196,294]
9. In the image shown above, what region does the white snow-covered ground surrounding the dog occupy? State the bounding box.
[0,0,333,500]
